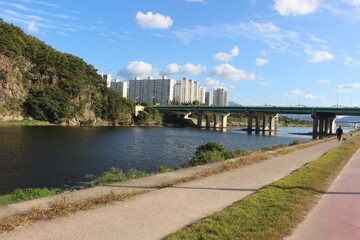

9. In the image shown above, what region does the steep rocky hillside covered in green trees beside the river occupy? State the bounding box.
[0,19,133,124]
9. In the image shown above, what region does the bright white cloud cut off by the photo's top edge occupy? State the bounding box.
[274,0,321,16]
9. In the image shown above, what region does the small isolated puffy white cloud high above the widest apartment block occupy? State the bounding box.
[136,12,174,29]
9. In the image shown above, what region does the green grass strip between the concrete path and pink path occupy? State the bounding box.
[167,136,360,240]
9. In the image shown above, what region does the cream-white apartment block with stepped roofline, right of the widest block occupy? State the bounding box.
[174,78,205,103]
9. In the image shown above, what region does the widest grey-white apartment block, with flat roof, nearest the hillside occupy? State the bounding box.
[128,77,175,105]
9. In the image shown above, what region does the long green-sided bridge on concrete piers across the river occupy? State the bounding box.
[155,106,360,134]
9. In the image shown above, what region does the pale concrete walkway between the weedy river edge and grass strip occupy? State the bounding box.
[0,140,348,240]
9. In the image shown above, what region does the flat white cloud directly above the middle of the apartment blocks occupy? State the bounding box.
[161,63,206,76]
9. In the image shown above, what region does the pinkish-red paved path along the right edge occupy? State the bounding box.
[286,150,360,240]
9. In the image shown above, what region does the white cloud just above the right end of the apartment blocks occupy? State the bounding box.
[210,63,255,81]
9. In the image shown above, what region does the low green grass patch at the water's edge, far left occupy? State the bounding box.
[0,188,56,206]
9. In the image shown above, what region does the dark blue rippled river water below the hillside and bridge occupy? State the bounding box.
[0,126,311,194]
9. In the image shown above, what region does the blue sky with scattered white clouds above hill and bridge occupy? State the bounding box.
[0,0,360,107]
